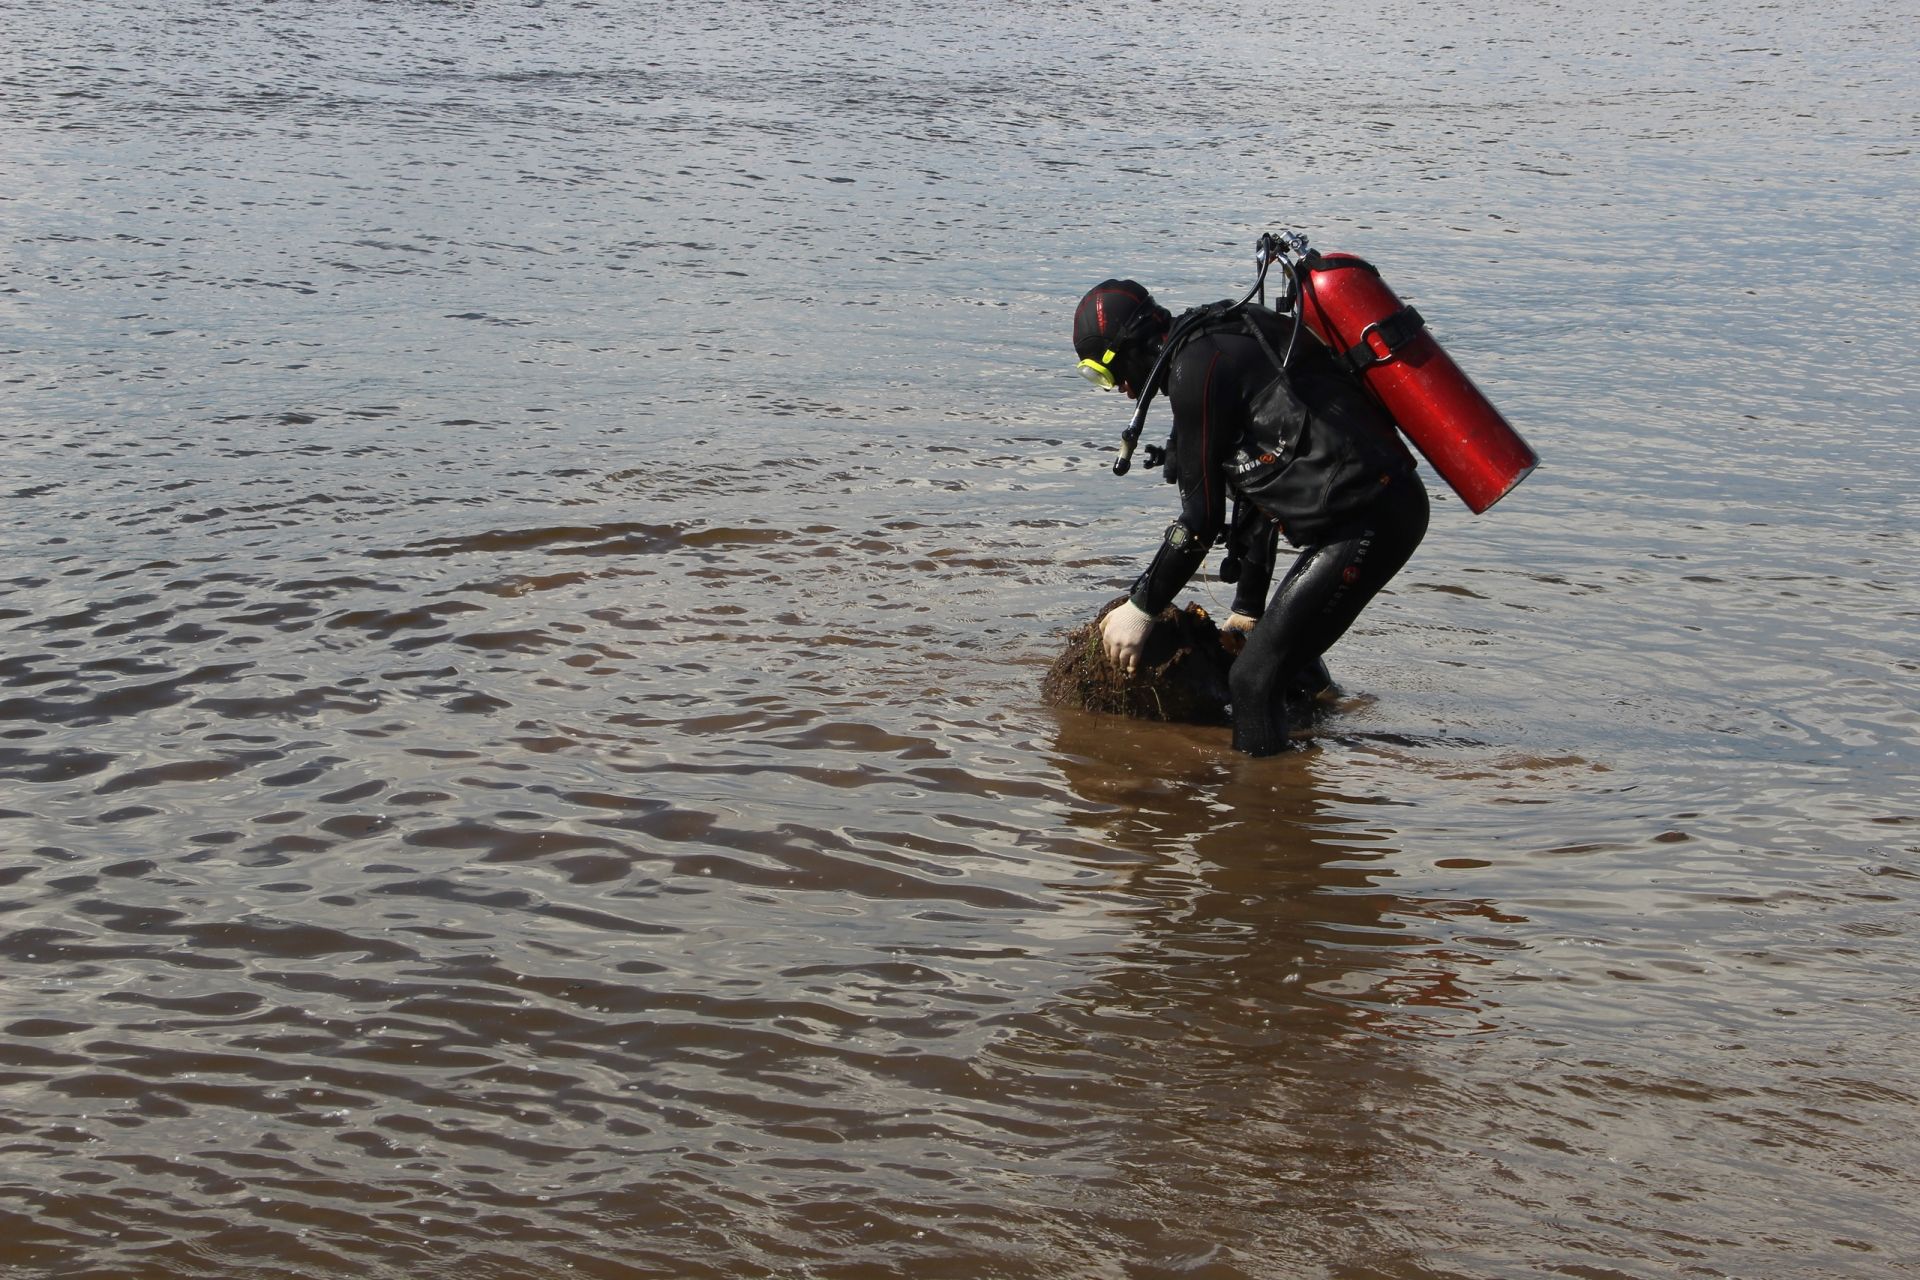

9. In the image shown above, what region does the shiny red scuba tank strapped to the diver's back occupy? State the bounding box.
[1296,253,1540,514]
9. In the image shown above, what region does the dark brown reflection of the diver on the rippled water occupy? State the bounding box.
[1000,716,1523,1274]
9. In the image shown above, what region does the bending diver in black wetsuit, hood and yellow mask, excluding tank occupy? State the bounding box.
[1073,280,1428,756]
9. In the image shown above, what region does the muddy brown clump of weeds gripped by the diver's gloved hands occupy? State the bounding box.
[1041,595,1242,723]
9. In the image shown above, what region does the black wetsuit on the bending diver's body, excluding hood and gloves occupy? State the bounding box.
[1133,307,1427,756]
